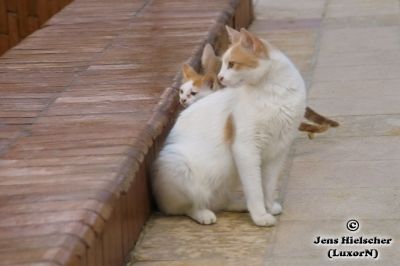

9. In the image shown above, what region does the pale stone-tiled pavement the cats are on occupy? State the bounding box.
[132,0,400,266]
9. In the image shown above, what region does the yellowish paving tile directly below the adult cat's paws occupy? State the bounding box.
[133,213,273,261]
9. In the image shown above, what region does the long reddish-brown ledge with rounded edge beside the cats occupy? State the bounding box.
[0,0,251,266]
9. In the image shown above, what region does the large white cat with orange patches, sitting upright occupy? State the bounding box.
[152,28,306,226]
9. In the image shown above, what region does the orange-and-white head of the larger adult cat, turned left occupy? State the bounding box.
[218,29,270,87]
